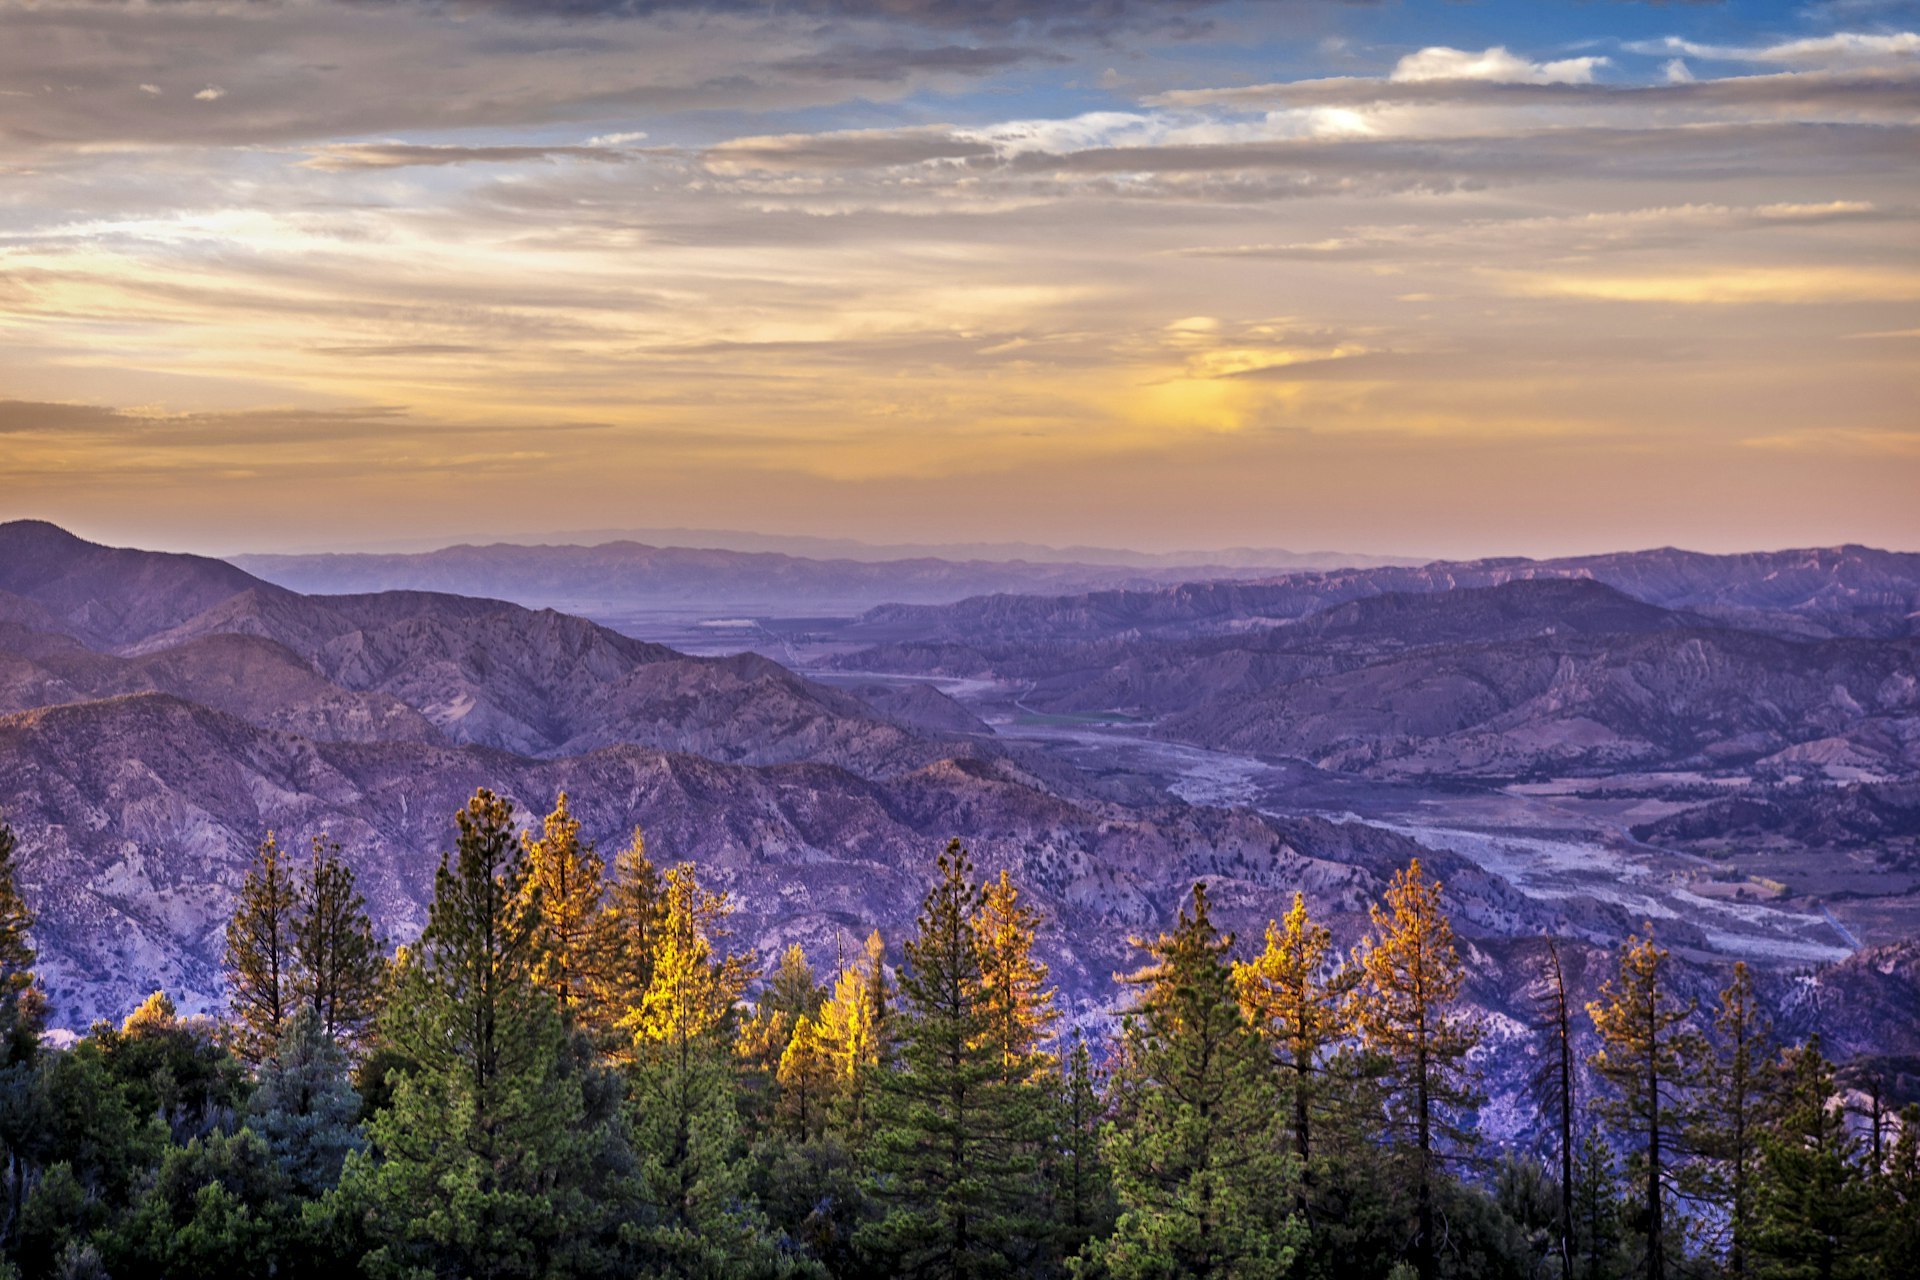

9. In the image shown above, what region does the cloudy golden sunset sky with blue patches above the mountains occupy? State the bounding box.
[0,0,1920,557]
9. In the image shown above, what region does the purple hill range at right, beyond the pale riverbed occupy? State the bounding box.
[835,578,1920,779]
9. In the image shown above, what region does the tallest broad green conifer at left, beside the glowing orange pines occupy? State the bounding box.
[342,789,610,1280]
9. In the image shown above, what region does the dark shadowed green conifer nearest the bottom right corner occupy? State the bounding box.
[1753,1038,1876,1280]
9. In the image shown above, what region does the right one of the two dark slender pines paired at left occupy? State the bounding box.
[294,837,388,1048]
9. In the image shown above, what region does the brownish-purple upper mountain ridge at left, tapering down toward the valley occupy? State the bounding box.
[0,522,970,771]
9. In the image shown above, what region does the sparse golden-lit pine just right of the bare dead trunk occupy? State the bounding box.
[1586,925,1703,1280]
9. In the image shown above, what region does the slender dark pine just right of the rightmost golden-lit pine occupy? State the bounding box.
[1690,961,1774,1280]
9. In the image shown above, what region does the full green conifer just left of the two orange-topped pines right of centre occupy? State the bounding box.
[1089,885,1306,1280]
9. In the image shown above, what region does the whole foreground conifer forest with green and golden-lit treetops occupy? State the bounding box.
[0,789,1920,1280]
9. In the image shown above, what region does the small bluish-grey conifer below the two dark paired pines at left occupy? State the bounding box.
[248,1006,367,1197]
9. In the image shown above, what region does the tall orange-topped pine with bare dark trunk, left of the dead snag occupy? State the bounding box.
[1352,858,1480,1280]
